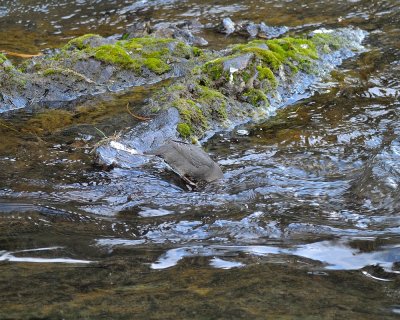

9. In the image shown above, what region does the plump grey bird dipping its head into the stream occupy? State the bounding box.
[148,140,223,185]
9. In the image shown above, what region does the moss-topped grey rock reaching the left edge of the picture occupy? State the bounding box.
[0,34,199,112]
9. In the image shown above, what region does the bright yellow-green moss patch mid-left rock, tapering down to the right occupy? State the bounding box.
[94,44,141,70]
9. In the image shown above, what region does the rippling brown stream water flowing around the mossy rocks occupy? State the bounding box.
[0,0,400,319]
